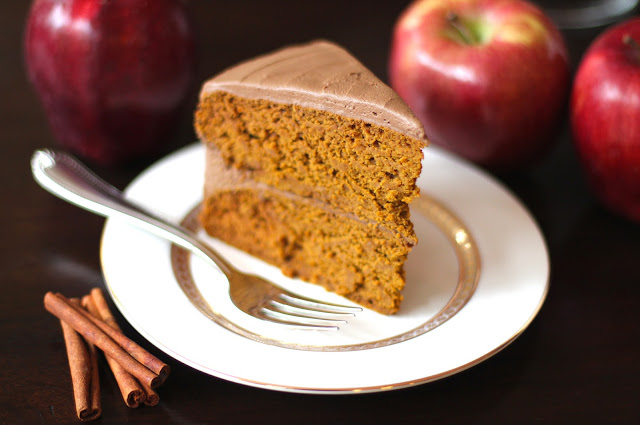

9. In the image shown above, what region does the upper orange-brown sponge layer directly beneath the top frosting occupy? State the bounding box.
[196,101,422,237]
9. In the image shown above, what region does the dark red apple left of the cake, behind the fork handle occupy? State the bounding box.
[24,0,195,164]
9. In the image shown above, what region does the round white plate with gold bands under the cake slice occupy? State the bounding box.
[101,144,549,393]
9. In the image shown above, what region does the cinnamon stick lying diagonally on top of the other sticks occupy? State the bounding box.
[44,292,166,388]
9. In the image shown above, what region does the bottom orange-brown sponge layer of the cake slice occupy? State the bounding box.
[200,188,410,314]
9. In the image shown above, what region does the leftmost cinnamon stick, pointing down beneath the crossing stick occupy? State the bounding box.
[60,300,102,421]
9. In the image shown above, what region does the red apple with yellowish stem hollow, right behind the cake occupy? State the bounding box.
[389,0,569,171]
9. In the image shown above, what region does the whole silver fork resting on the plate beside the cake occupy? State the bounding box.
[31,149,362,330]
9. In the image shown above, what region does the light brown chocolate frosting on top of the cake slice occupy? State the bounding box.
[200,40,427,144]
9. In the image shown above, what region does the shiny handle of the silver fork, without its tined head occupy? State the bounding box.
[31,149,235,276]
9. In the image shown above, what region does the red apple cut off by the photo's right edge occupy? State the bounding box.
[570,18,640,222]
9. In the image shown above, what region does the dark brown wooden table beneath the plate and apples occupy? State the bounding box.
[0,0,640,425]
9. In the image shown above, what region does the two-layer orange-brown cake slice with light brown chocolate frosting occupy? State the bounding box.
[195,41,427,314]
